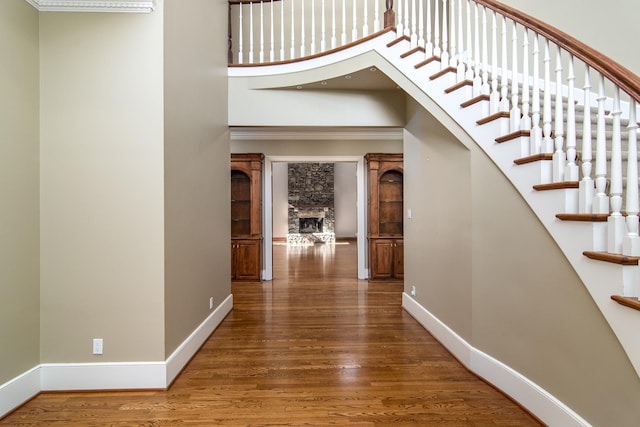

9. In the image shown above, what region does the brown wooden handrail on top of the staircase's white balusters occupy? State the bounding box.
[474,0,640,102]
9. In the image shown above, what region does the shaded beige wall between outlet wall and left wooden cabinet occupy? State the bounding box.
[164,0,231,357]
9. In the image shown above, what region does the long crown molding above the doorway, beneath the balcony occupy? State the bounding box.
[229,127,403,141]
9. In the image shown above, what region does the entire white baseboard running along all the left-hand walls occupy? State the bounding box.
[0,295,233,417]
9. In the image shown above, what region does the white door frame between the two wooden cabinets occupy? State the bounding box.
[262,155,369,280]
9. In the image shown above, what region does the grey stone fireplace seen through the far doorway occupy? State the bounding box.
[287,163,335,245]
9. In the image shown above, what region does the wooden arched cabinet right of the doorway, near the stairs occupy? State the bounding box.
[365,153,404,280]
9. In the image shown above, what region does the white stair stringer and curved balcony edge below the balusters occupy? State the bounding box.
[229,31,640,384]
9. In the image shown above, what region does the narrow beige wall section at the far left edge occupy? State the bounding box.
[0,0,40,384]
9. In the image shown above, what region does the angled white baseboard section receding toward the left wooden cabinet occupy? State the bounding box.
[165,294,233,387]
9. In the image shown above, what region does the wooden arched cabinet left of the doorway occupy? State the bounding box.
[231,153,264,281]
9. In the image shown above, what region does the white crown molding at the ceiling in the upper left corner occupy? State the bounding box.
[26,0,156,13]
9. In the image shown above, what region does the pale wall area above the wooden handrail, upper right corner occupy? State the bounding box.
[502,0,640,74]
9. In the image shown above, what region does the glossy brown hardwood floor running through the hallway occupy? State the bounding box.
[0,244,540,426]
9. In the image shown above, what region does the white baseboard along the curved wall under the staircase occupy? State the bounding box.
[402,293,590,426]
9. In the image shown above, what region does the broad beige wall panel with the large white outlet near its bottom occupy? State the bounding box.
[40,8,164,363]
